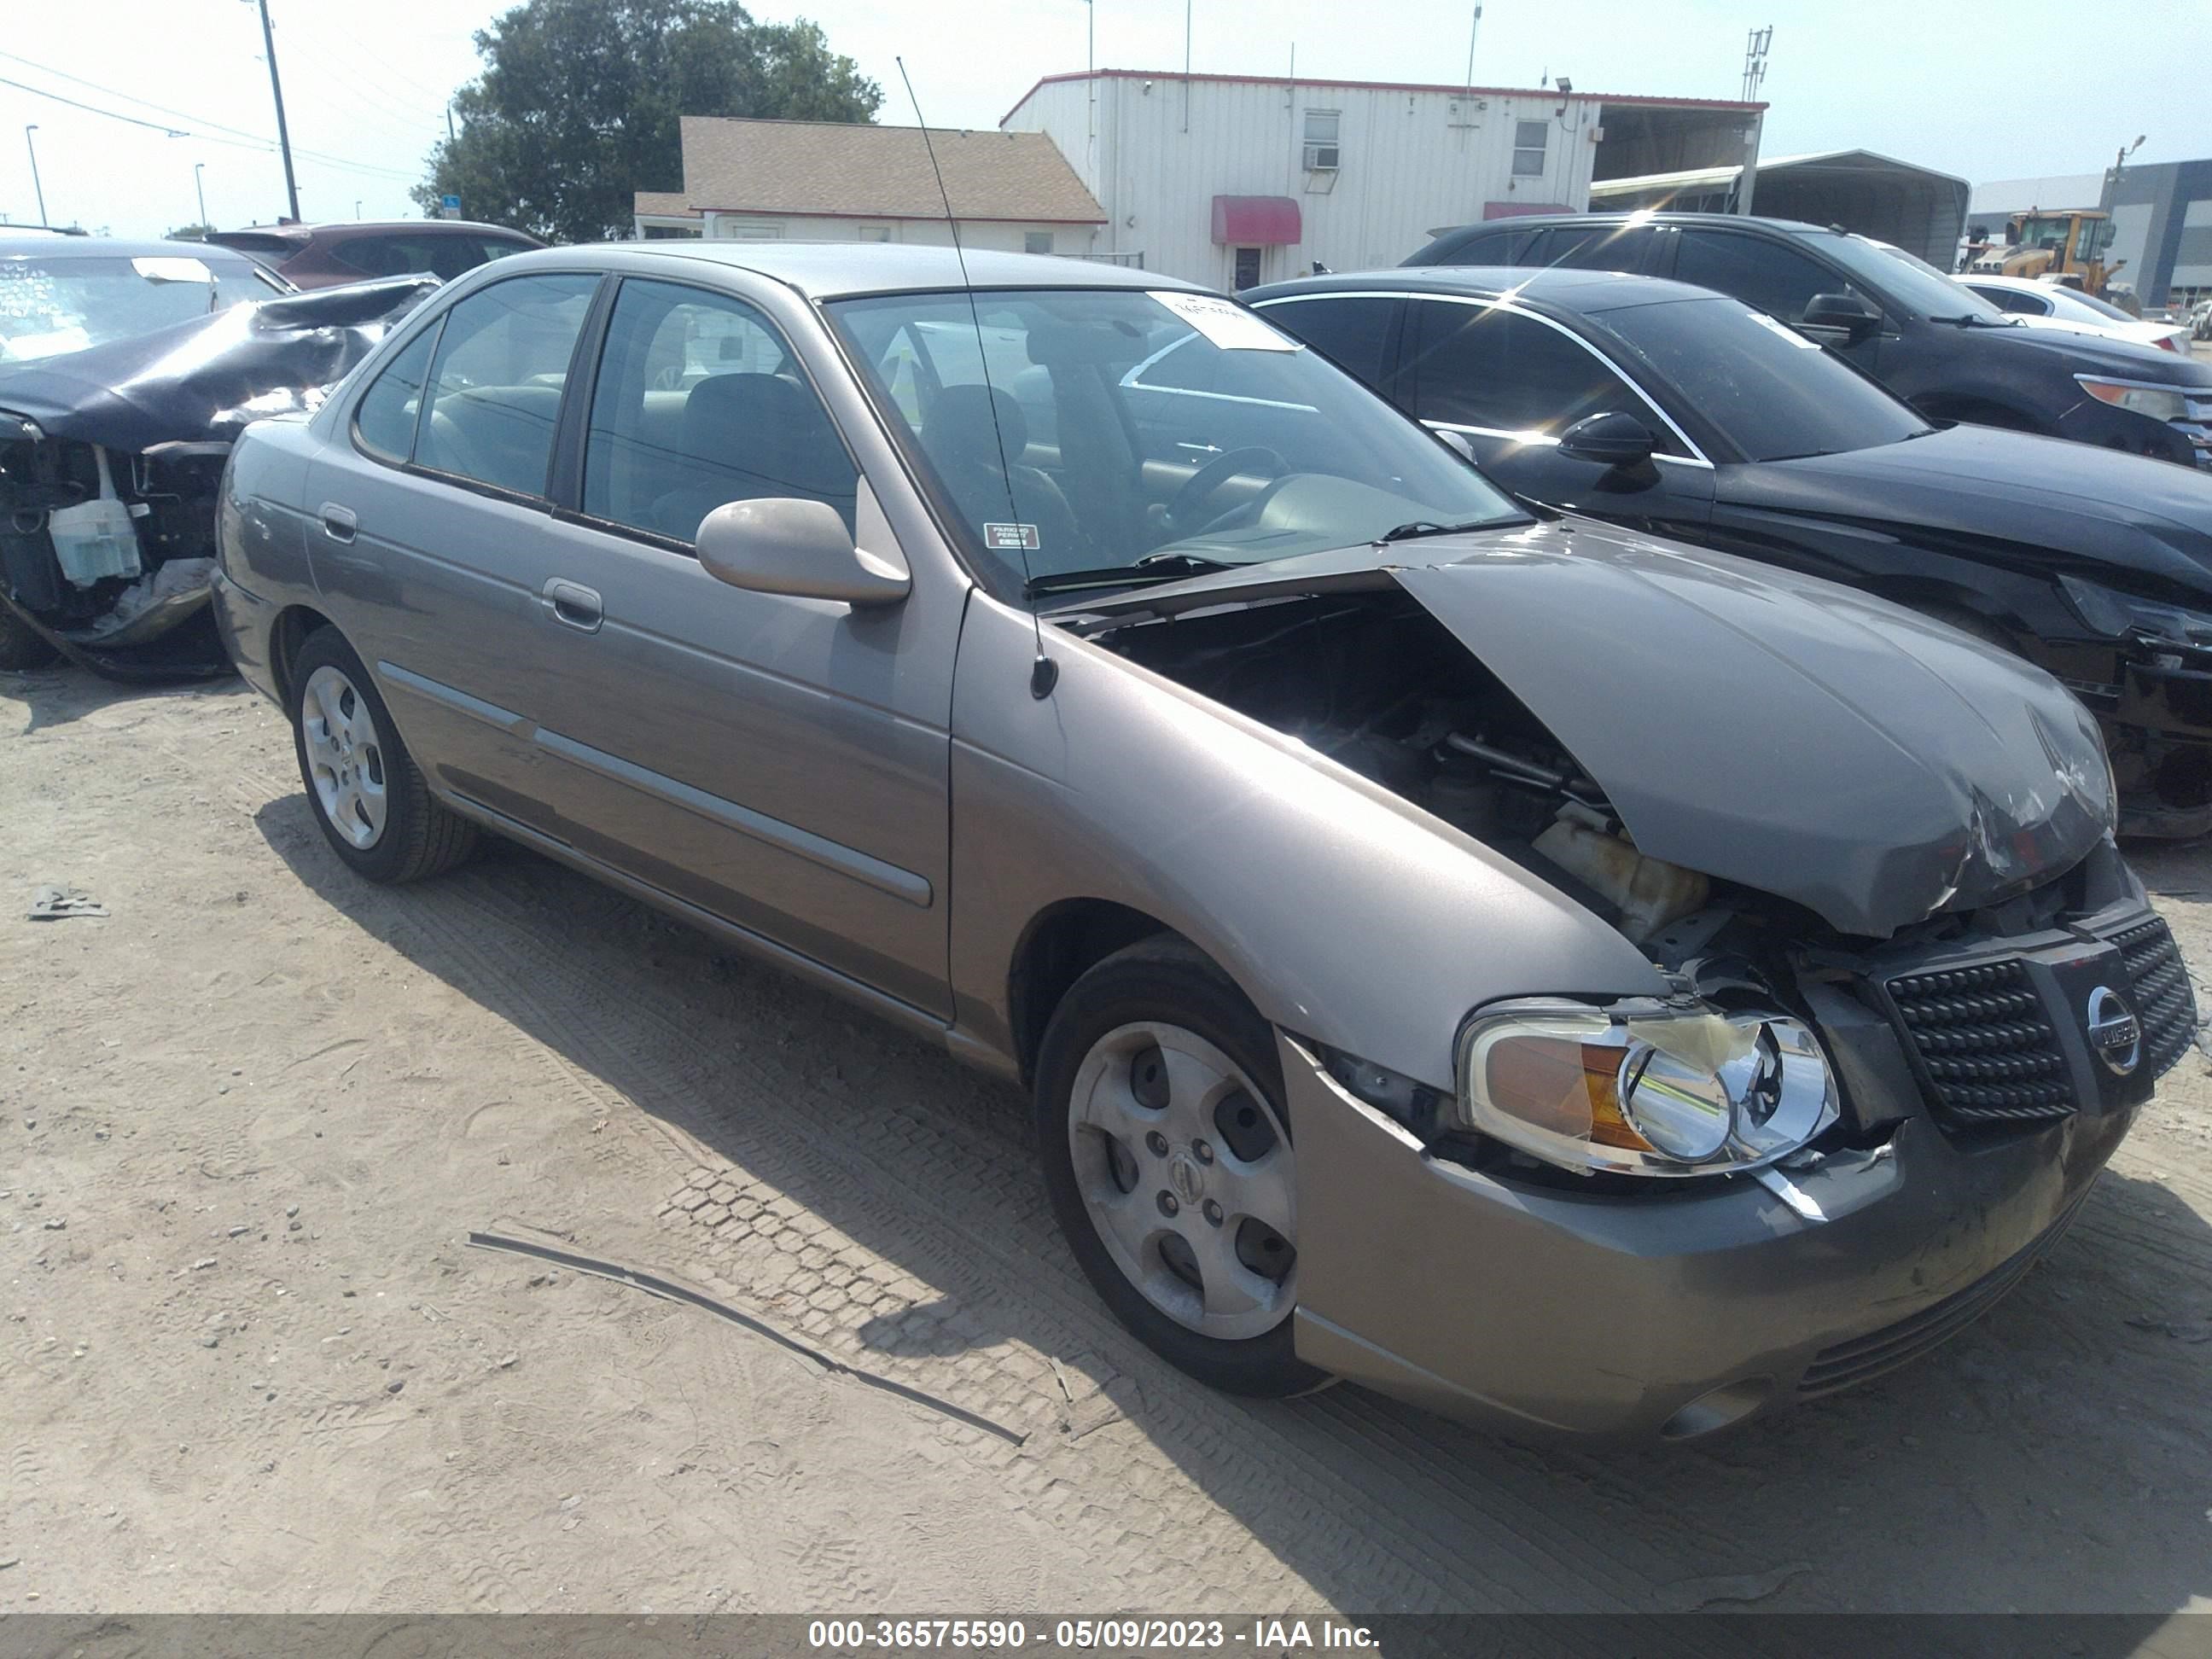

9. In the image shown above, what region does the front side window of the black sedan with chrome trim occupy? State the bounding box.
[1413,301,1685,456]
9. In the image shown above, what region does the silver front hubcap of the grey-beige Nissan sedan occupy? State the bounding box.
[1068,1022,1299,1341]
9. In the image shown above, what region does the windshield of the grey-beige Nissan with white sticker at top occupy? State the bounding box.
[830,288,1522,593]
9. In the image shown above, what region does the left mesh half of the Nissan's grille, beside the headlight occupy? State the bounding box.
[1889,959,2070,1128]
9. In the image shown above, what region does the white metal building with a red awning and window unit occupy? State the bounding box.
[1000,68,1765,288]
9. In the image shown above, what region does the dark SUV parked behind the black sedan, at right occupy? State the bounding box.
[1405,212,2212,467]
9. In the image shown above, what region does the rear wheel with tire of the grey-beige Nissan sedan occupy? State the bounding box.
[292,628,478,887]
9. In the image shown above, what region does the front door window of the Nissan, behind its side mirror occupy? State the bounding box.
[584,279,859,542]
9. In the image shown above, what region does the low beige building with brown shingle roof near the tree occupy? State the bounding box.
[635,115,1106,254]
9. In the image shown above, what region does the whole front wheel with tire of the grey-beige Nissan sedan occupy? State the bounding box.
[1035,938,1330,1398]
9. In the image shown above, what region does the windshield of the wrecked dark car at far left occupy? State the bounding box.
[0,250,283,363]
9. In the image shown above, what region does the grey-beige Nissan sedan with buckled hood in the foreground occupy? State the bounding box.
[214,243,2194,1438]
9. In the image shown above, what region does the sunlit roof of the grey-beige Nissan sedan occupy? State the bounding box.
[562,239,1206,299]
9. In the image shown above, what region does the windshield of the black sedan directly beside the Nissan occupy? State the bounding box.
[1591,296,1929,460]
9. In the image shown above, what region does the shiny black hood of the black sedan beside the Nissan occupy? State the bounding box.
[1714,427,2212,599]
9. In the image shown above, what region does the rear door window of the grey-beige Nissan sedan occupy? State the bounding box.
[414,272,599,496]
